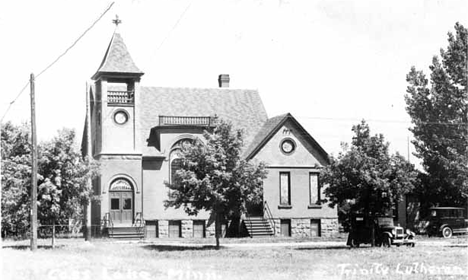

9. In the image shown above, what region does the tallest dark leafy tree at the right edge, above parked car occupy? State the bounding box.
[405,23,468,208]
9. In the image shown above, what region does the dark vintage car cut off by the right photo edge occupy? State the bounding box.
[426,207,468,238]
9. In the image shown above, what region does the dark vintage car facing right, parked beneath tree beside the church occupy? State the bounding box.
[347,215,416,247]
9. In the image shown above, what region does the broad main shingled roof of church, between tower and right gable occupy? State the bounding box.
[140,87,268,155]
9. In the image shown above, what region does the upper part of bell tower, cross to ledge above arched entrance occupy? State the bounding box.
[92,17,144,157]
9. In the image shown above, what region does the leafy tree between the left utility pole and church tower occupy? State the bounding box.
[38,128,98,242]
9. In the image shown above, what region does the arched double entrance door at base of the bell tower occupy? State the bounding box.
[109,179,134,224]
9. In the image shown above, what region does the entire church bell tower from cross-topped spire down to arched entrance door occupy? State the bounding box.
[91,17,144,226]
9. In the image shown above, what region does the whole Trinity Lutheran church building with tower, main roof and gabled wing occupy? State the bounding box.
[82,28,338,238]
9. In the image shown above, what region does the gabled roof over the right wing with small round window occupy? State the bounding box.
[244,113,329,162]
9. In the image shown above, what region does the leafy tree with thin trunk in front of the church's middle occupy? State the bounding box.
[165,121,266,248]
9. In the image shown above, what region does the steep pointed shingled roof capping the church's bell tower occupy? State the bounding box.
[92,32,144,80]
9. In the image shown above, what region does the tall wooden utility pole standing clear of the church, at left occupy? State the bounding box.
[29,73,37,251]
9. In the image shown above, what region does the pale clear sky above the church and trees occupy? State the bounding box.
[0,0,468,163]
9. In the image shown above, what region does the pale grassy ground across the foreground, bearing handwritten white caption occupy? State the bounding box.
[2,238,468,280]
